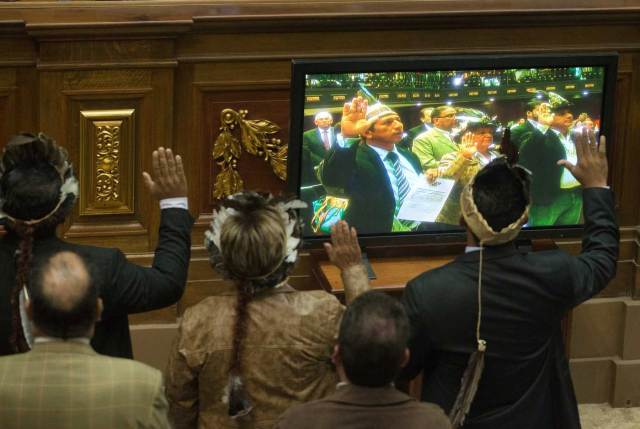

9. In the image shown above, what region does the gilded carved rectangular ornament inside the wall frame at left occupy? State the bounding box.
[95,126,120,201]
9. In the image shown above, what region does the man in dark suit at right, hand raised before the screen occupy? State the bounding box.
[403,131,618,429]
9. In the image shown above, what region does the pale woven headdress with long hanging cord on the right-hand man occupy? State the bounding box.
[449,128,531,428]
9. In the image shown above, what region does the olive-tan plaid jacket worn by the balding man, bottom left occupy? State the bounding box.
[0,341,170,429]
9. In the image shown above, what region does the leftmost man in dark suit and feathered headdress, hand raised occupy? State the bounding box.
[0,133,193,358]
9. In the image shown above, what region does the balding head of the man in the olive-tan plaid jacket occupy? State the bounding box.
[28,251,98,339]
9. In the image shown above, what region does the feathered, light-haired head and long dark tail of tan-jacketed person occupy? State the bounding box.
[206,192,300,418]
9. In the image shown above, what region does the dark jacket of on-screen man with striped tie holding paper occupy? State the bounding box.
[319,141,422,234]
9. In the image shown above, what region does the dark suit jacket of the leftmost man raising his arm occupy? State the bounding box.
[0,208,193,358]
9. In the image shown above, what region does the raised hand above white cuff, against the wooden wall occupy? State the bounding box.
[142,147,187,200]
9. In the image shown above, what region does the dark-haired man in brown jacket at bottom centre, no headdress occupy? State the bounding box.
[275,292,451,429]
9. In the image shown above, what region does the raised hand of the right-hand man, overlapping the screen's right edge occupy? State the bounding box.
[558,128,609,188]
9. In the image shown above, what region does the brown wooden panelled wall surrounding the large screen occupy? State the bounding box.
[0,0,640,322]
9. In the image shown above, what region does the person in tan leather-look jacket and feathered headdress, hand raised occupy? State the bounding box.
[167,192,369,429]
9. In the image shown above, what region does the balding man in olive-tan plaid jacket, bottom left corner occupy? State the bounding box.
[0,251,170,429]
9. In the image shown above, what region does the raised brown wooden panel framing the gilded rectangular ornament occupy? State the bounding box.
[38,35,176,252]
